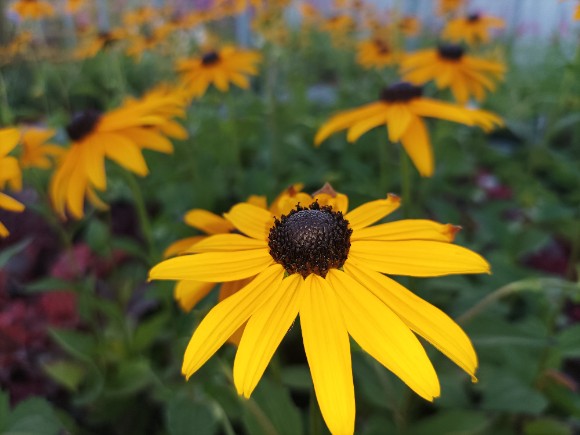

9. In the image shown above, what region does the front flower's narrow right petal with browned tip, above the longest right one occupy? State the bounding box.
[351,219,461,242]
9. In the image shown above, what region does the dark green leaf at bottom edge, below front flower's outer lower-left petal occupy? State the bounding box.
[166,396,219,435]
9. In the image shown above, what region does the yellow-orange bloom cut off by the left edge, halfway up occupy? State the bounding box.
[0,128,24,237]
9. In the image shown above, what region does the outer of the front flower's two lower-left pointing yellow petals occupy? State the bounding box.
[181,264,284,378]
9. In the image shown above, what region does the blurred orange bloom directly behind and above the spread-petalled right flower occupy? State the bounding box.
[401,44,505,104]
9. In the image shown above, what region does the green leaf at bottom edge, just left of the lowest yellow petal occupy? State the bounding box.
[242,377,302,435]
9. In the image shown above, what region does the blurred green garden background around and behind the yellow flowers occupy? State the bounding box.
[0,0,580,435]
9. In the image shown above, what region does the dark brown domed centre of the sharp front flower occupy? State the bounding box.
[268,202,352,278]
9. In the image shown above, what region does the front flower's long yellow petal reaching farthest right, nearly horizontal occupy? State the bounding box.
[348,240,490,276]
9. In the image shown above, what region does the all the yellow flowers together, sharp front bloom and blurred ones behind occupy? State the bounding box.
[0,0,536,433]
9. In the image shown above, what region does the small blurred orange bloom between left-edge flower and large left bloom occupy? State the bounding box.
[20,127,64,169]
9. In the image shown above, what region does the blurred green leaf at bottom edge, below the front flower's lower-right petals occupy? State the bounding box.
[407,410,490,435]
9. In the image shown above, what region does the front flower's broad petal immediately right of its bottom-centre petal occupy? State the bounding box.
[326,269,440,401]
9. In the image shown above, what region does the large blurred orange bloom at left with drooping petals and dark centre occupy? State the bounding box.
[49,87,187,219]
